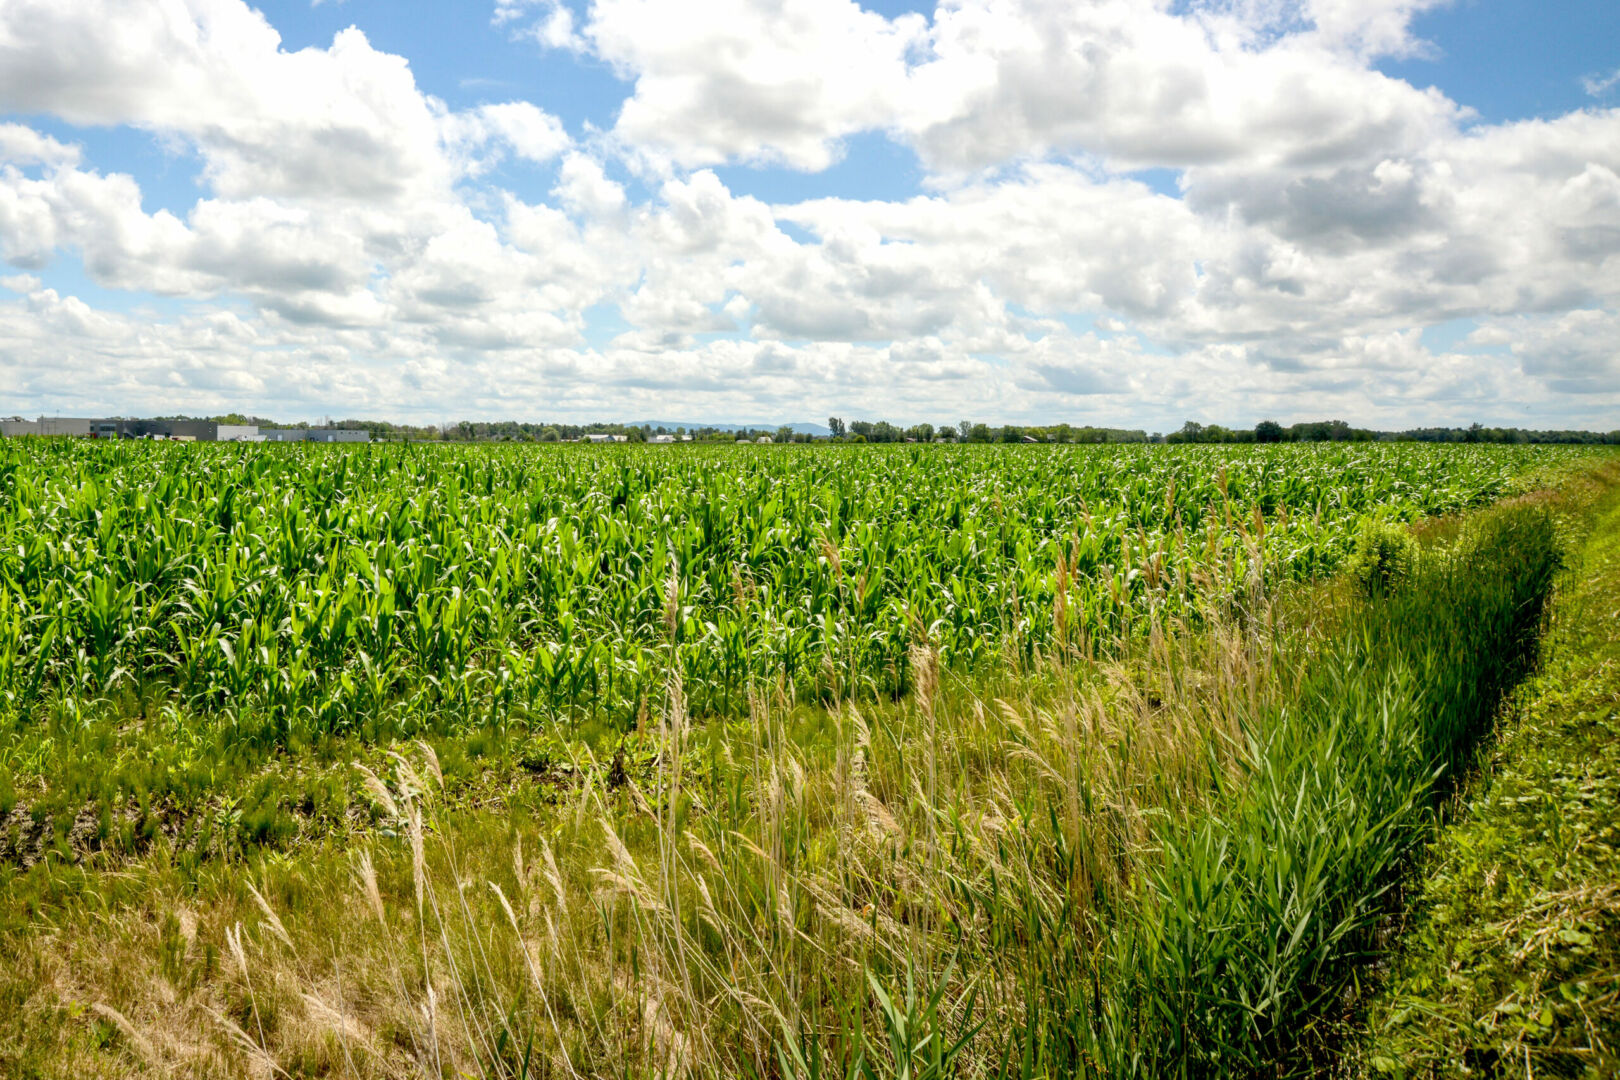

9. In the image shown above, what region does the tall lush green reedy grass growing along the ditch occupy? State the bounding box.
[1022,500,1562,1077]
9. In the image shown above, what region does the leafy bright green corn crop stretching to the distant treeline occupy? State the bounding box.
[0,442,1571,740]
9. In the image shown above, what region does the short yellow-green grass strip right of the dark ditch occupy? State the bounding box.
[1354,468,1620,1077]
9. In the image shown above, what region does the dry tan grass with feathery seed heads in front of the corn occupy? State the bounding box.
[3,565,1308,1078]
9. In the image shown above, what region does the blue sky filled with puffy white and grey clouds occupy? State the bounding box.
[0,0,1620,431]
